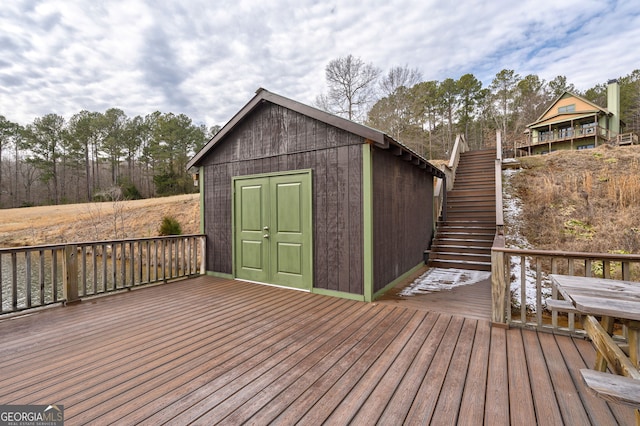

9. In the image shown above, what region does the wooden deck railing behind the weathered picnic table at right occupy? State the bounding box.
[492,248,640,334]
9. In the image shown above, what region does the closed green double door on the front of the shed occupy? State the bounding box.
[233,172,313,290]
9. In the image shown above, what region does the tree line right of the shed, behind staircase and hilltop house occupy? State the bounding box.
[315,55,640,159]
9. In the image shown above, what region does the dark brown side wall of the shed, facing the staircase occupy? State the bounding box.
[372,148,433,292]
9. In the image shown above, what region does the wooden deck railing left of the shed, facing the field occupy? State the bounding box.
[0,235,205,314]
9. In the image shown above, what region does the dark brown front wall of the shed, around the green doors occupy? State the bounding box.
[202,103,364,294]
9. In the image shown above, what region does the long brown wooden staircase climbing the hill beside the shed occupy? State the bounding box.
[428,150,496,271]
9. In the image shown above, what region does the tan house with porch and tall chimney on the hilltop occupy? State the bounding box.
[518,80,637,155]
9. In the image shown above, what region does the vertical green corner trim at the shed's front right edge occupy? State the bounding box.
[362,144,373,302]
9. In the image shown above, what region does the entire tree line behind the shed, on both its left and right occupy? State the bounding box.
[0,55,640,208]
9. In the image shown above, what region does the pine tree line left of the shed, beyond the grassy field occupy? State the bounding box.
[0,108,219,208]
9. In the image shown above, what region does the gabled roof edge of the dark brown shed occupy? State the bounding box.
[187,88,444,178]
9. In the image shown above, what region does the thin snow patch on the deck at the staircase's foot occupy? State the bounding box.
[399,268,491,296]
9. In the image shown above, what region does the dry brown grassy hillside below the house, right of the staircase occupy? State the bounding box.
[506,145,640,254]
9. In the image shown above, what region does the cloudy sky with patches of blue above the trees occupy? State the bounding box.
[0,0,640,126]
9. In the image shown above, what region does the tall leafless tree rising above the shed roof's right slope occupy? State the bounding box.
[316,55,380,121]
